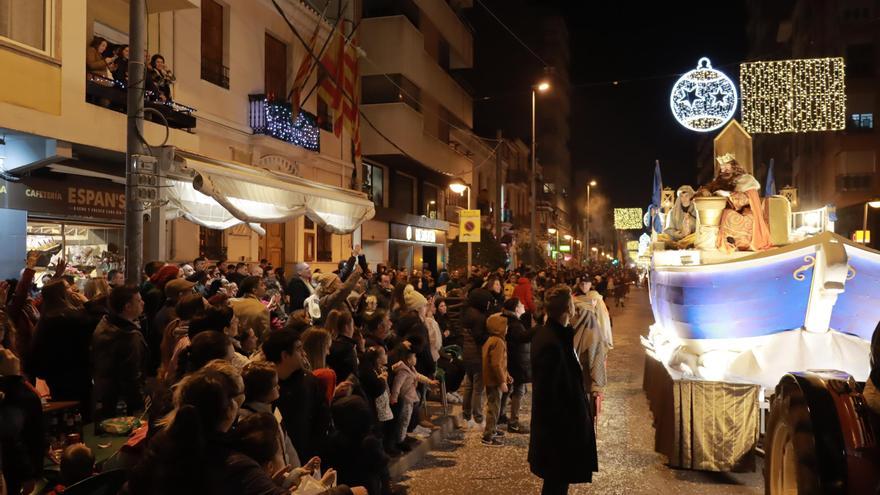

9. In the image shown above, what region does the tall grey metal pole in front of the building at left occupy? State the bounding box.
[125,0,147,284]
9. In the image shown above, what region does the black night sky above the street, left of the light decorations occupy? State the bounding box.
[468,0,747,211]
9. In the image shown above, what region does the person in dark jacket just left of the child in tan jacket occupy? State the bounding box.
[461,287,492,428]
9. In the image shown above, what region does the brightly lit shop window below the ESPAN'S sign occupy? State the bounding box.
[26,221,124,284]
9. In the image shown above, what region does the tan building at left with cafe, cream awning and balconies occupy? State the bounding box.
[0,0,373,276]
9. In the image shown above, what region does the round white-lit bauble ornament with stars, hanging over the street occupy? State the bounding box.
[669,57,737,132]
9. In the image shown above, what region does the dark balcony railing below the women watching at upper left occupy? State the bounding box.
[86,74,196,131]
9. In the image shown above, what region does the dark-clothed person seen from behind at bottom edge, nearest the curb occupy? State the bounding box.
[322,395,390,495]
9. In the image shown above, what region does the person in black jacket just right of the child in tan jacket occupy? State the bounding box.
[498,297,535,433]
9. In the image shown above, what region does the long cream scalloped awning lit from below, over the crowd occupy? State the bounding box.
[168,151,376,234]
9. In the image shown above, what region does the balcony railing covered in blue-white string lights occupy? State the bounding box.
[248,94,321,151]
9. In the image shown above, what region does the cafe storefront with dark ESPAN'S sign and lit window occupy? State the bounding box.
[0,173,125,283]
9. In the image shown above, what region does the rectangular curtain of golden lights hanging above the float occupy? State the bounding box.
[740,57,846,134]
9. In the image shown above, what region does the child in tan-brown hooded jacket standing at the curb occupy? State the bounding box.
[482,313,513,446]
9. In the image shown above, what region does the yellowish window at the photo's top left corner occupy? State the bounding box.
[0,0,54,53]
